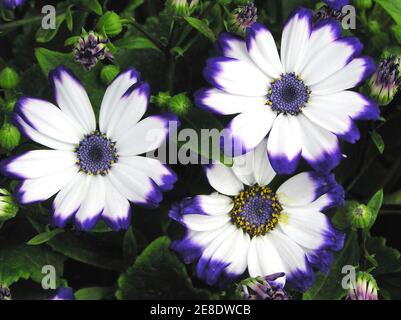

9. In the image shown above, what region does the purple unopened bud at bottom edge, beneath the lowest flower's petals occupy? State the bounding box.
[237,272,288,300]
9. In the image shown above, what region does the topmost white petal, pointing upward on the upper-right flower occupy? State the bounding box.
[281,8,312,73]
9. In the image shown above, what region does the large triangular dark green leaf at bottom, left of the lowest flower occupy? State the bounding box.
[116,237,209,300]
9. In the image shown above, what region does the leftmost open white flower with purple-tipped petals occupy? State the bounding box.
[0,67,176,230]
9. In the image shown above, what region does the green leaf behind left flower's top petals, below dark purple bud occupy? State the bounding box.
[35,48,104,114]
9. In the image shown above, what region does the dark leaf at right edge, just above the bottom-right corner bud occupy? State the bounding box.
[366,237,401,275]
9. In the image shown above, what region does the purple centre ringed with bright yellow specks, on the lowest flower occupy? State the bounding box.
[230,185,282,236]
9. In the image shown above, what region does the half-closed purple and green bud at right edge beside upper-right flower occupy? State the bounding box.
[369,56,401,105]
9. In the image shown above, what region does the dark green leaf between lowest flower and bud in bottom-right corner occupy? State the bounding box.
[303,231,359,300]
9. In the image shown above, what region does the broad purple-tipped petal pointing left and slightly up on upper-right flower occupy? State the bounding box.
[204,57,271,97]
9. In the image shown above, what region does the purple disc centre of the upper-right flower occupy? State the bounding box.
[266,73,310,115]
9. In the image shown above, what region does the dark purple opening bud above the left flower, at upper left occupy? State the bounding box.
[74,31,114,71]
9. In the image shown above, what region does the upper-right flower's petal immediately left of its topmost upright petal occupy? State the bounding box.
[246,23,284,79]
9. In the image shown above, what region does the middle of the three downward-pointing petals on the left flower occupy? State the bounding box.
[75,176,106,230]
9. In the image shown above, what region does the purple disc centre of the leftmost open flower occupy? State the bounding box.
[75,131,118,175]
